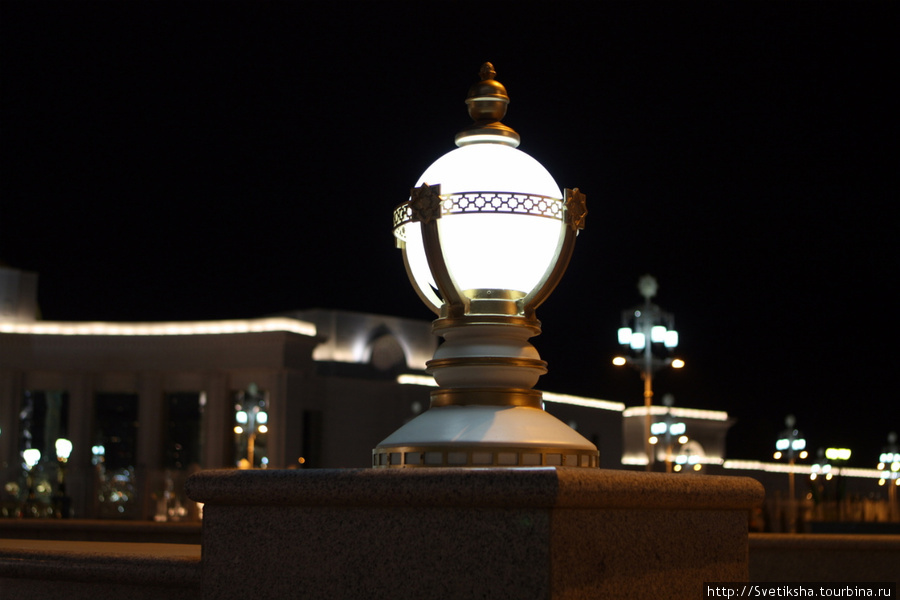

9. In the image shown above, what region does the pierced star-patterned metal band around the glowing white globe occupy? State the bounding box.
[394,186,566,240]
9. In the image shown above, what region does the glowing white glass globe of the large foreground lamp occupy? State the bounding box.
[406,144,564,306]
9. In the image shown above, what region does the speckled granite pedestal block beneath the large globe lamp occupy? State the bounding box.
[187,467,763,600]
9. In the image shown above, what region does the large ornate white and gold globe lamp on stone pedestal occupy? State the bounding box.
[373,63,598,468]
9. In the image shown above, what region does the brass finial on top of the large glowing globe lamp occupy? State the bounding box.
[456,62,519,148]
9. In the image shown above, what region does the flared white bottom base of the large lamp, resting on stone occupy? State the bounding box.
[372,404,599,468]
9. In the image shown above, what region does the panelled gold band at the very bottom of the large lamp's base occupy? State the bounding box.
[372,446,600,469]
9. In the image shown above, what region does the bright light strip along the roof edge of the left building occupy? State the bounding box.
[0,317,316,336]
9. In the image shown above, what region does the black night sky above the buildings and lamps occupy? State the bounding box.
[0,2,900,467]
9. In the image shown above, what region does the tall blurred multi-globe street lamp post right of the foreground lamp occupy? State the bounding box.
[613,275,684,471]
